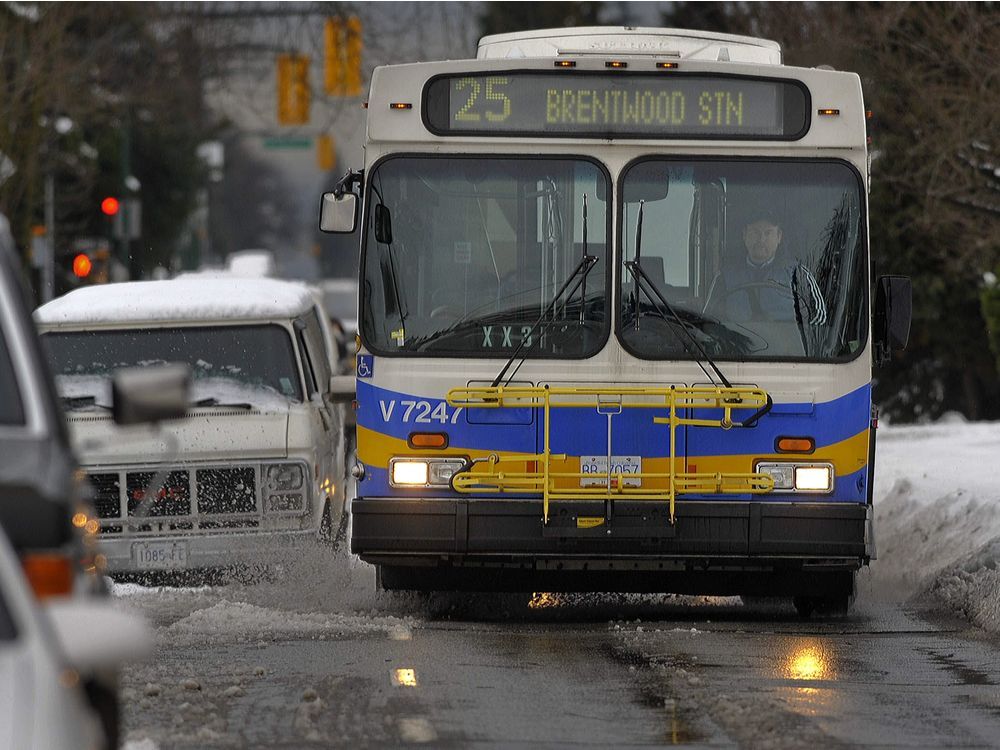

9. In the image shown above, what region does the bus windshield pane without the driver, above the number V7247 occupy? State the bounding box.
[361,156,611,358]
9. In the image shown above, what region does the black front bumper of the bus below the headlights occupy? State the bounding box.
[351,497,875,594]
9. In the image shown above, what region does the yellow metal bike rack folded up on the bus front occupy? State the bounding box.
[446,385,774,524]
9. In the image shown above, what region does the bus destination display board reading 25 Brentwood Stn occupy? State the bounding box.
[424,71,808,140]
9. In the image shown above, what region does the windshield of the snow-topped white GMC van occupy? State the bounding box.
[42,324,302,400]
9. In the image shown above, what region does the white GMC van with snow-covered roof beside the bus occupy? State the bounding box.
[35,277,353,572]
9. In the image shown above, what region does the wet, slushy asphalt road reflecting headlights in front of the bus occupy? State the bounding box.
[122,551,1000,748]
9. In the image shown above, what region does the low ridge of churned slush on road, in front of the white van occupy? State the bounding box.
[165,600,411,643]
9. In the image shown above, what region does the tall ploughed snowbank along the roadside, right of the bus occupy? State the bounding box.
[872,419,1000,631]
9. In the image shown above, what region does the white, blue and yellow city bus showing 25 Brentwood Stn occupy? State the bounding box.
[320,27,910,615]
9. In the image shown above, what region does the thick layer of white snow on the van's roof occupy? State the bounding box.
[35,277,315,325]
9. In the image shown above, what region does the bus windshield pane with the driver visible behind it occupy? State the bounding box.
[619,159,867,361]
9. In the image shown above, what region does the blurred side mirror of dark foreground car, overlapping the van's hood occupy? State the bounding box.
[111,364,191,425]
